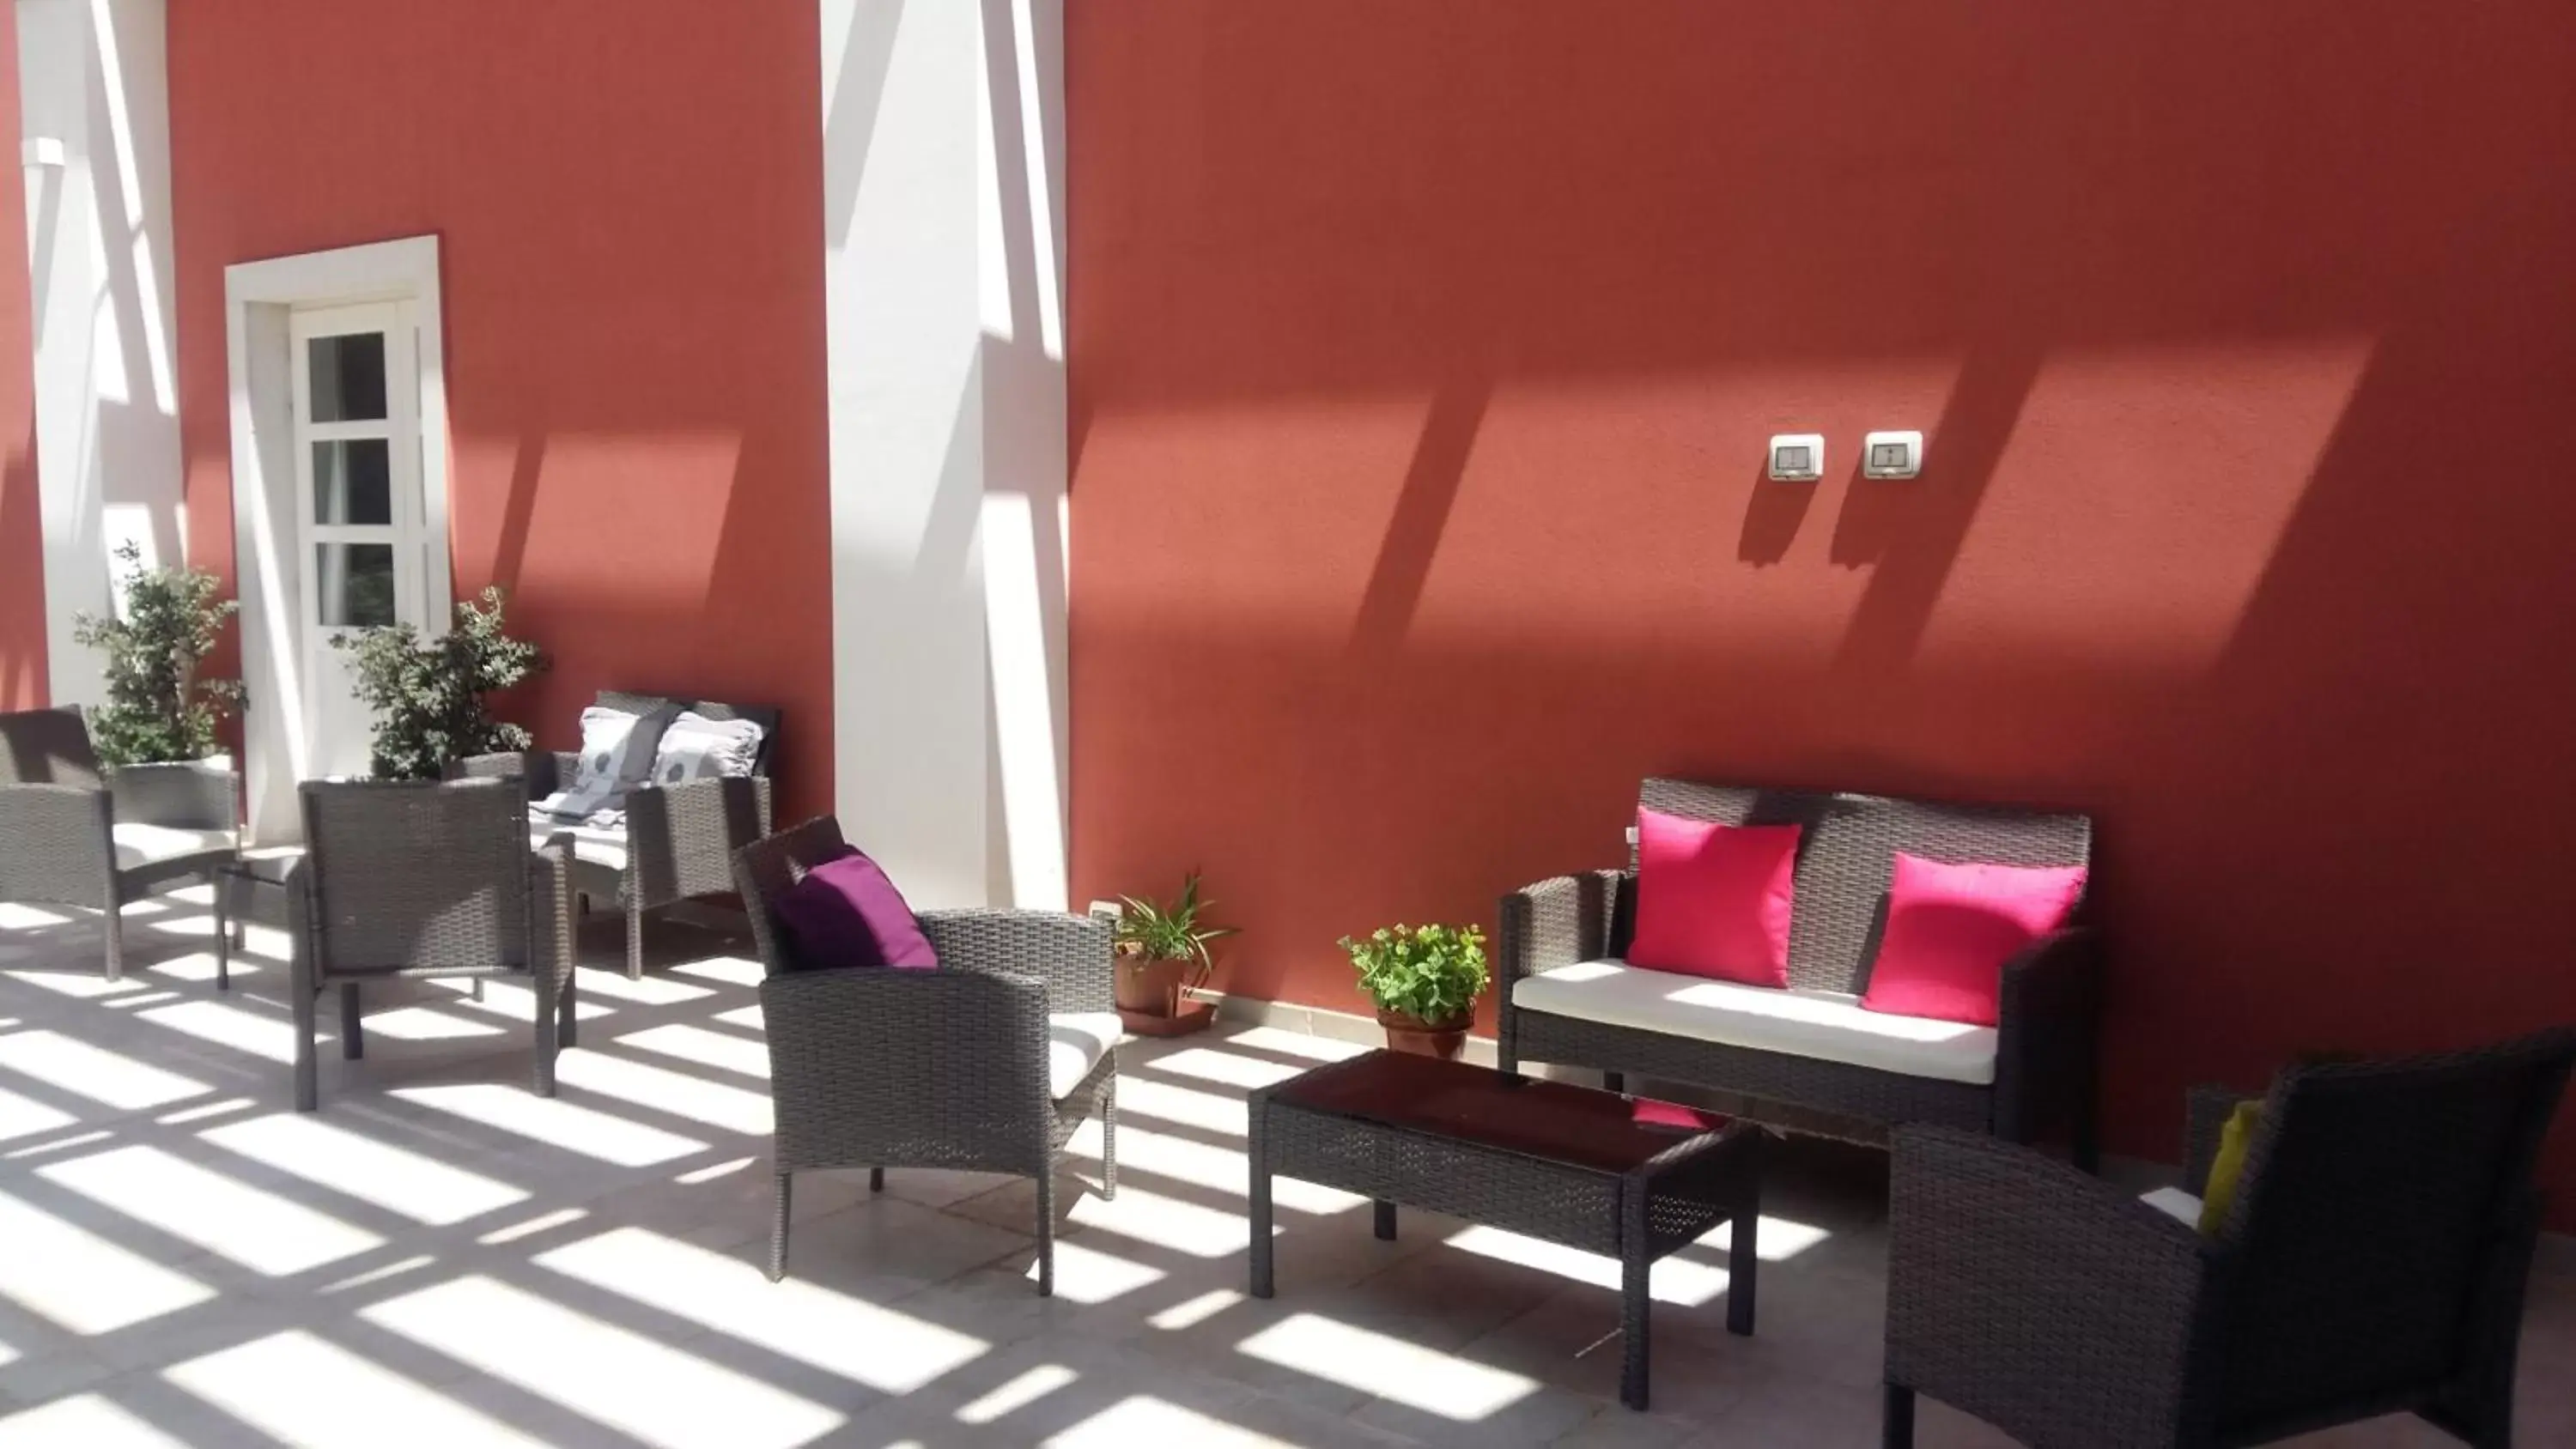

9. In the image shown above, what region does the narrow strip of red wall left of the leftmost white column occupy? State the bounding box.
[0,8,46,711]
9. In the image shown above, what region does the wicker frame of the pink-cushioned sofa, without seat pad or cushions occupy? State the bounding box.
[1494,779,2102,1168]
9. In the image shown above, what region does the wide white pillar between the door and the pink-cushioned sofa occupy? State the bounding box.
[819,0,1066,908]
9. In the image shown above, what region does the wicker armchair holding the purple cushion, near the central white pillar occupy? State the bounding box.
[734,818,1118,1294]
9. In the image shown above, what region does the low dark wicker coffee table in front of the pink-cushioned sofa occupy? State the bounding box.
[1249,1050,1762,1408]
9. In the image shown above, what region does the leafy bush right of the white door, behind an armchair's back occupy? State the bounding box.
[330,587,546,779]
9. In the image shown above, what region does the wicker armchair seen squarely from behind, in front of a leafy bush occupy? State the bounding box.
[286,779,574,1112]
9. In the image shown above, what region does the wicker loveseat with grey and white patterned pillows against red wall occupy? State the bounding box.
[448,690,778,980]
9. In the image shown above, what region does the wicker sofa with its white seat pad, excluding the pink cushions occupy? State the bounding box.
[1497,779,2102,1168]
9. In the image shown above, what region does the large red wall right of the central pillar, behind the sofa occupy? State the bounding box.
[1066,0,2576,1225]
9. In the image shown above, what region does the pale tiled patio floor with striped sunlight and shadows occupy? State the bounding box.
[0,898,2576,1449]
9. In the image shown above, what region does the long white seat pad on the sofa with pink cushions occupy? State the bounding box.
[1512,960,1996,1086]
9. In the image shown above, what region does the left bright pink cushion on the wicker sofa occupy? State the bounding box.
[1628,810,1798,985]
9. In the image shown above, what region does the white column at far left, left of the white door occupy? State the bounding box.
[15,0,185,706]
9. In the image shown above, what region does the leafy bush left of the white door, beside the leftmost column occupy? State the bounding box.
[72,541,242,764]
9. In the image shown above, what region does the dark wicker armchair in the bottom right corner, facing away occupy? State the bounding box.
[1886,1029,2576,1449]
